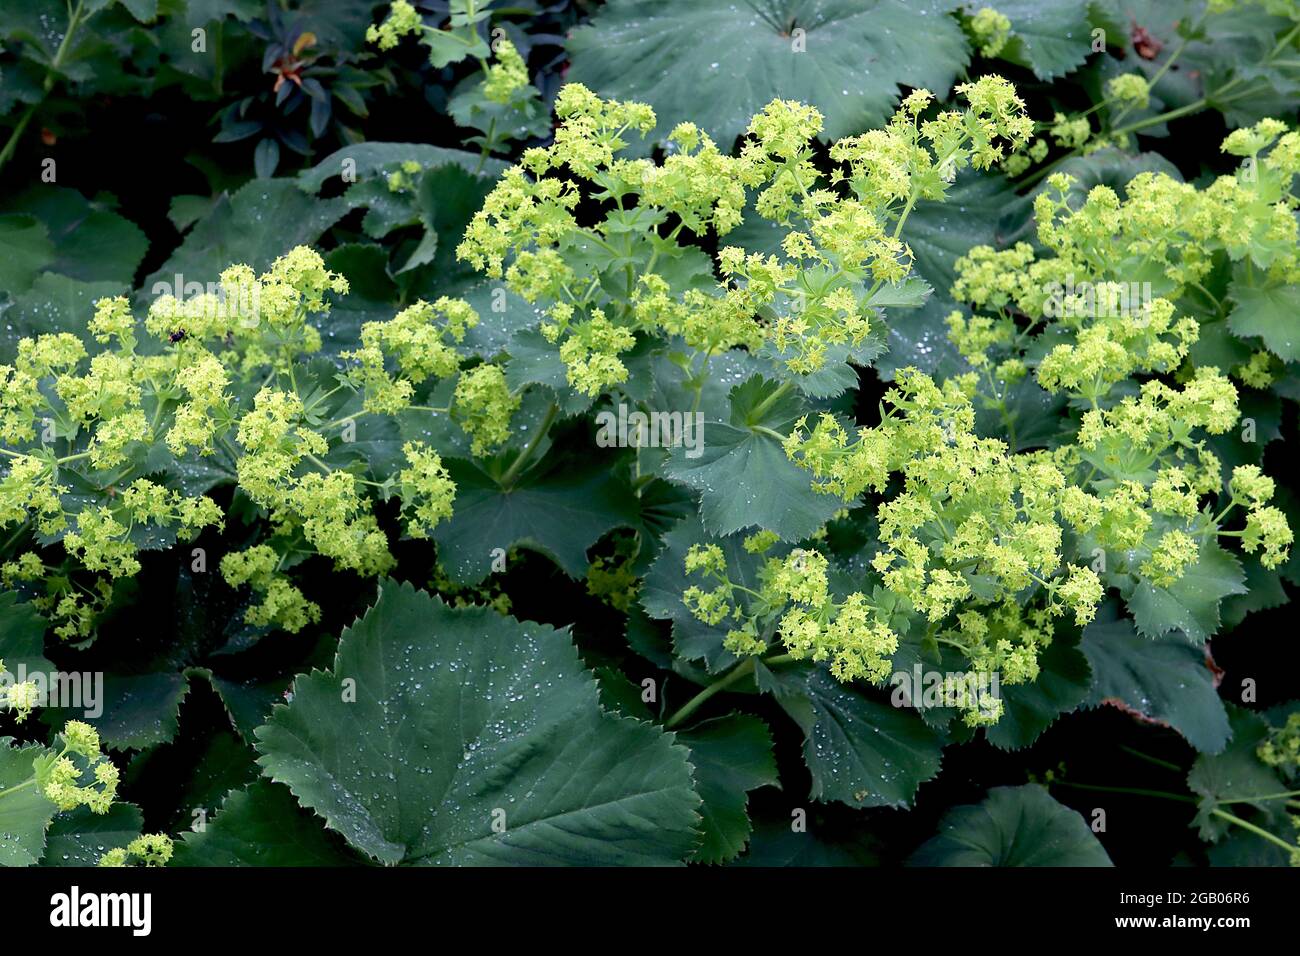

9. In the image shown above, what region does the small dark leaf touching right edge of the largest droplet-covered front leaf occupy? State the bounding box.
[679,714,781,864]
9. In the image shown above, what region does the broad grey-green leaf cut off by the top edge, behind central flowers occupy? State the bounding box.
[568,0,967,150]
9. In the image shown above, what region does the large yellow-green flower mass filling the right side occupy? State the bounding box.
[759,124,1300,717]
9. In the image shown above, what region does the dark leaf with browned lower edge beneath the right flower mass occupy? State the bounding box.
[1082,606,1229,753]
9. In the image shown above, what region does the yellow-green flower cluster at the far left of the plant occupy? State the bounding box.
[0,247,465,647]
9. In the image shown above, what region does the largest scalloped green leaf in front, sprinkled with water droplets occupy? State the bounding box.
[257,583,699,865]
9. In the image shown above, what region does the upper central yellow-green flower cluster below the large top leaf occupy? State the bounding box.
[456,77,1032,398]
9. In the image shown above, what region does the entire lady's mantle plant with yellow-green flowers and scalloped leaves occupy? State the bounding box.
[0,0,1300,866]
